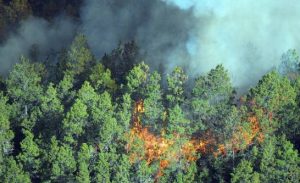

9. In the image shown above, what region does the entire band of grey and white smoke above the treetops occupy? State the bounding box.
[0,0,300,88]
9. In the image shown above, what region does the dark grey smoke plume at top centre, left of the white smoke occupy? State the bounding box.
[81,0,196,68]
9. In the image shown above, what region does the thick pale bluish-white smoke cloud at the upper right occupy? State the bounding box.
[164,0,300,87]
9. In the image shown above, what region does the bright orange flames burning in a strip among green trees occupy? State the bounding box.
[126,100,263,178]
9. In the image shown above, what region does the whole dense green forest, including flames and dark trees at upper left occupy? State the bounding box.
[0,0,300,183]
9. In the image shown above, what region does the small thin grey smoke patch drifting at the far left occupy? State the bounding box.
[0,16,76,74]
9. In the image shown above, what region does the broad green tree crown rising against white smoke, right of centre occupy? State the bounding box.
[190,65,234,130]
